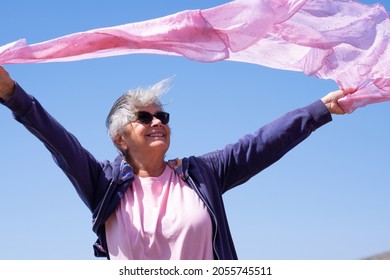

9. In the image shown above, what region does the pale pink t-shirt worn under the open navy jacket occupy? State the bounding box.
[105,166,213,260]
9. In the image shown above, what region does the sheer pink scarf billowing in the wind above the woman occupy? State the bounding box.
[0,0,390,112]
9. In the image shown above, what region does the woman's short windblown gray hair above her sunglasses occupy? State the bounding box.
[106,77,173,143]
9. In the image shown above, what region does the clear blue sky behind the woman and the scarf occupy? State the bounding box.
[0,0,390,259]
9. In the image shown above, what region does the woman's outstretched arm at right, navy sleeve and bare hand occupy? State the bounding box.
[204,89,355,192]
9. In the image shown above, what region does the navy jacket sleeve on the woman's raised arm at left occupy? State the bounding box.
[2,84,105,210]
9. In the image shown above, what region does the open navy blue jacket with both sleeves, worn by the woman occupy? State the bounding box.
[3,84,332,260]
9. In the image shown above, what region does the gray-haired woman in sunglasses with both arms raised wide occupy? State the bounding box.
[0,67,354,260]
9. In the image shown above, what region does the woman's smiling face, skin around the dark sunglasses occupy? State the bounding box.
[118,104,171,161]
